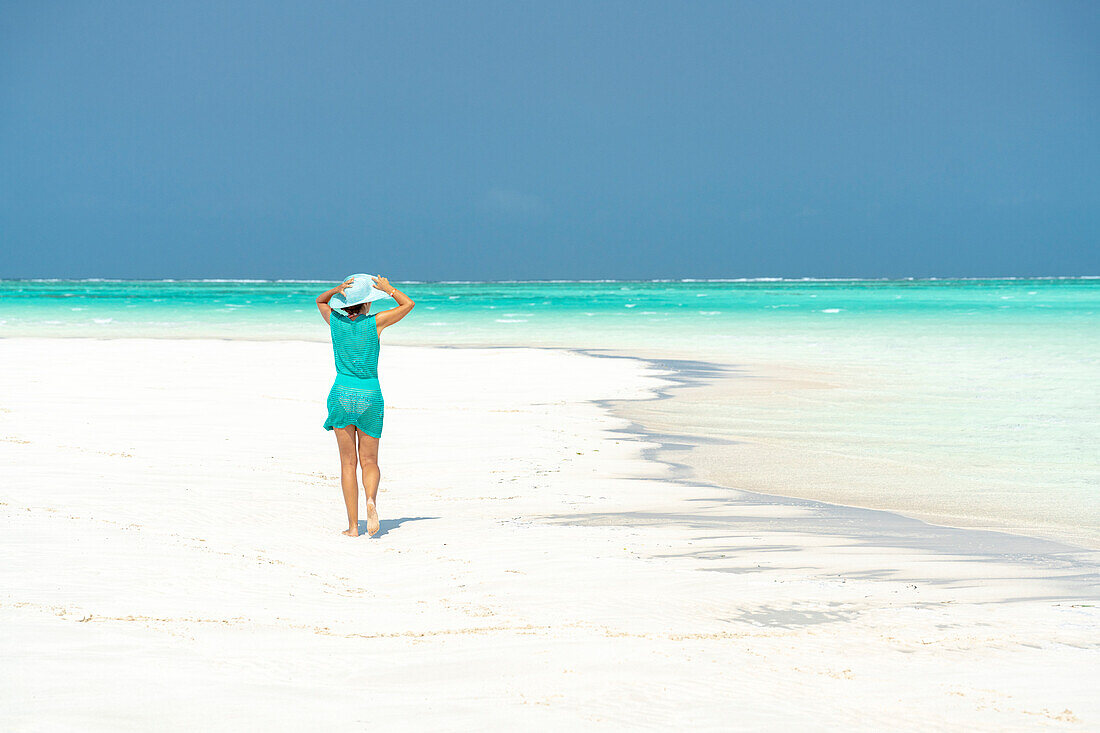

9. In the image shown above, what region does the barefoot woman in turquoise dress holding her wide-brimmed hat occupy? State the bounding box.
[317,275,416,537]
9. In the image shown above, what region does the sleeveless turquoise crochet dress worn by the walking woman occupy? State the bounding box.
[325,310,385,438]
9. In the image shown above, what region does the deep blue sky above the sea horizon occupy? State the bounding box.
[0,0,1100,281]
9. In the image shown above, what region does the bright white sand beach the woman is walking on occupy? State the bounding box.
[0,338,1100,731]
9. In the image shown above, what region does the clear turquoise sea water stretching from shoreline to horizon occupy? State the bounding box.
[0,278,1100,546]
